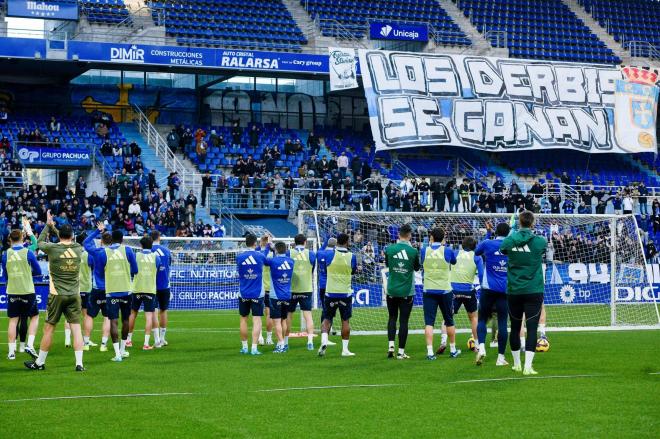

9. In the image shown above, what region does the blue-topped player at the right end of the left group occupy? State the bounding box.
[151,230,172,348]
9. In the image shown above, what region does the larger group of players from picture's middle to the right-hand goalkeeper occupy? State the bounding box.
[236,211,548,375]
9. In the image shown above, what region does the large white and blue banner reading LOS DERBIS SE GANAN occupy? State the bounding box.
[359,50,658,153]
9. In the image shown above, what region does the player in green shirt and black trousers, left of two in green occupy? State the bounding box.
[385,224,421,360]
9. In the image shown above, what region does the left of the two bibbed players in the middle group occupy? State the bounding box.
[285,233,316,351]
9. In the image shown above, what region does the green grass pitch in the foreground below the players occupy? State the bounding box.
[0,312,660,439]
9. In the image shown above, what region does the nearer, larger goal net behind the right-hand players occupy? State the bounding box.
[299,211,660,333]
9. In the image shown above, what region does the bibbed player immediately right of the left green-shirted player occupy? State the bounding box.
[421,227,461,360]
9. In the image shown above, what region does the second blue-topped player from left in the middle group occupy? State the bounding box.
[265,241,294,354]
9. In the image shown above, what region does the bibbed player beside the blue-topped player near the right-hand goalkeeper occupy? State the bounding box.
[449,236,484,350]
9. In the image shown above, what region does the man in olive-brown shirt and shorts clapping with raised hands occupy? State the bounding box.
[25,211,85,372]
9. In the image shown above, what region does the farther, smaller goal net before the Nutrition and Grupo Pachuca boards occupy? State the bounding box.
[124,236,316,310]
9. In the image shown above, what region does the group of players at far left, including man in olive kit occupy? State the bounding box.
[2,212,171,372]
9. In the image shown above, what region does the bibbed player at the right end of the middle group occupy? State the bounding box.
[319,233,357,357]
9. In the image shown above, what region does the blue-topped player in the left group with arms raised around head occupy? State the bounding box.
[83,229,112,352]
